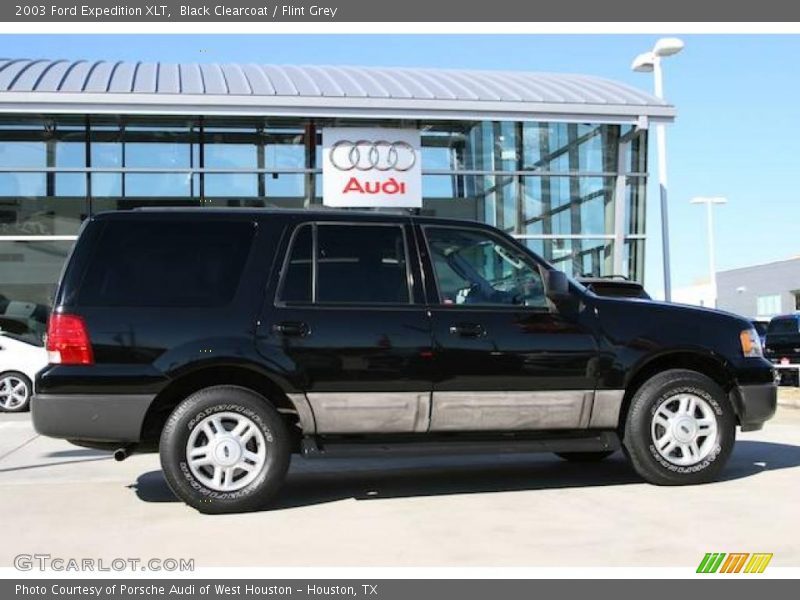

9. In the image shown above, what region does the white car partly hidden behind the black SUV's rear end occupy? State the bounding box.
[0,331,47,412]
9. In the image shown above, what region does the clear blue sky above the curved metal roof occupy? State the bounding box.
[0,34,800,297]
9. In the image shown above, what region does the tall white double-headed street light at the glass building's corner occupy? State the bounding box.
[631,38,683,302]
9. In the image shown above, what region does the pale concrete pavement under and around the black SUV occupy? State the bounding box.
[0,407,800,567]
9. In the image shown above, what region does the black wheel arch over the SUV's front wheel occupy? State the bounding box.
[618,350,739,434]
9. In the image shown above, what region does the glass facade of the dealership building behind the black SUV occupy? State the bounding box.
[0,115,647,338]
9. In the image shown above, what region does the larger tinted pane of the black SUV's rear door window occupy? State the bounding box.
[317,224,409,304]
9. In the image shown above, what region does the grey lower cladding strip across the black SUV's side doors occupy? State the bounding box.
[289,390,624,435]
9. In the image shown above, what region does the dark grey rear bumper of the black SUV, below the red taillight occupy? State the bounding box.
[31,394,155,442]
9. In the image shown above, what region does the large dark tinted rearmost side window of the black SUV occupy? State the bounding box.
[78,221,253,307]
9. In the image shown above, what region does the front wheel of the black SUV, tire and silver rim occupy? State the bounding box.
[623,369,736,485]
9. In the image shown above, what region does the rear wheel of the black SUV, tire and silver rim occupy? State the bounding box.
[159,386,291,514]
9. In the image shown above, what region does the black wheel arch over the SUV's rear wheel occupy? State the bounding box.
[141,364,300,445]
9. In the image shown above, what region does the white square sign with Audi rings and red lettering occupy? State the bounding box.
[322,127,422,208]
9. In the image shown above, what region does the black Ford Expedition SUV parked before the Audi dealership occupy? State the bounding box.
[33,209,776,512]
